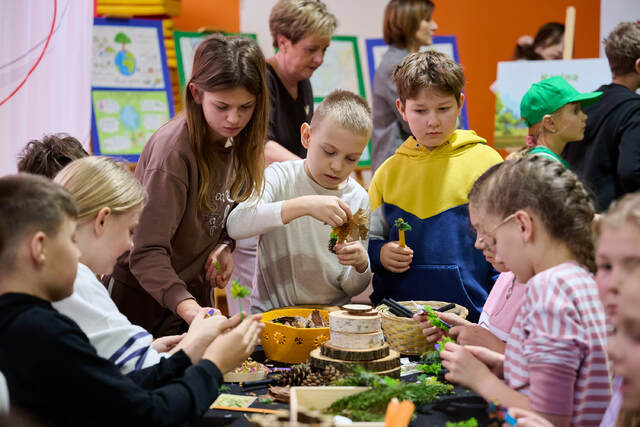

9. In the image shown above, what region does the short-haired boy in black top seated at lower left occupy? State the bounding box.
[0,174,261,426]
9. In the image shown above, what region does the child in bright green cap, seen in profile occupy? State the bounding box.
[520,76,602,168]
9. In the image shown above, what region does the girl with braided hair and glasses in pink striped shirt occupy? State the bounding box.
[441,156,611,426]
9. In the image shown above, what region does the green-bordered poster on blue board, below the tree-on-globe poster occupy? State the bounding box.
[92,90,170,155]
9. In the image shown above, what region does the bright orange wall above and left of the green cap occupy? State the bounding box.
[434,0,600,144]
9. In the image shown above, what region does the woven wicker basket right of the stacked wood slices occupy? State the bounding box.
[376,301,469,355]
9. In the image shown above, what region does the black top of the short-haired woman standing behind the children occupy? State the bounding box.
[267,63,313,158]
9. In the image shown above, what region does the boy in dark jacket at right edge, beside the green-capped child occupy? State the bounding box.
[563,22,640,212]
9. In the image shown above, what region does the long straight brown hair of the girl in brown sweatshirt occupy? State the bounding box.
[185,35,269,211]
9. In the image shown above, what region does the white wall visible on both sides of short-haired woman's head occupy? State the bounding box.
[240,0,388,99]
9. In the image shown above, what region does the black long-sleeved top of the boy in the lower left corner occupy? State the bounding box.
[0,294,222,426]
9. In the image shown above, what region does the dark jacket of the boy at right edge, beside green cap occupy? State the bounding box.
[562,83,640,212]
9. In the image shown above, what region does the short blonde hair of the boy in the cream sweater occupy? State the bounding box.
[311,90,373,139]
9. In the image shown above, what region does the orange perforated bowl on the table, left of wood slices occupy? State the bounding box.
[260,308,329,363]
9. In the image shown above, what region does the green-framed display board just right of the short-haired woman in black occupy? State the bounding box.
[311,36,371,168]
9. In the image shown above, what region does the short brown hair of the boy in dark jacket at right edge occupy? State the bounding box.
[604,22,640,76]
